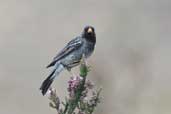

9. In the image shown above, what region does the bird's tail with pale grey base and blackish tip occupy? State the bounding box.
[40,63,64,95]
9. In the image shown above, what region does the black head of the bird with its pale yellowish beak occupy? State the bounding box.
[83,26,96,43]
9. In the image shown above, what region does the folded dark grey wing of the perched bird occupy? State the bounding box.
[47,37,83,68]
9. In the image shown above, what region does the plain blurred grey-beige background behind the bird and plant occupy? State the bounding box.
[0,0,171,114]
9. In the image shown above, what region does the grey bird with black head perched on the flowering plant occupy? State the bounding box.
[40,26,96,96]
